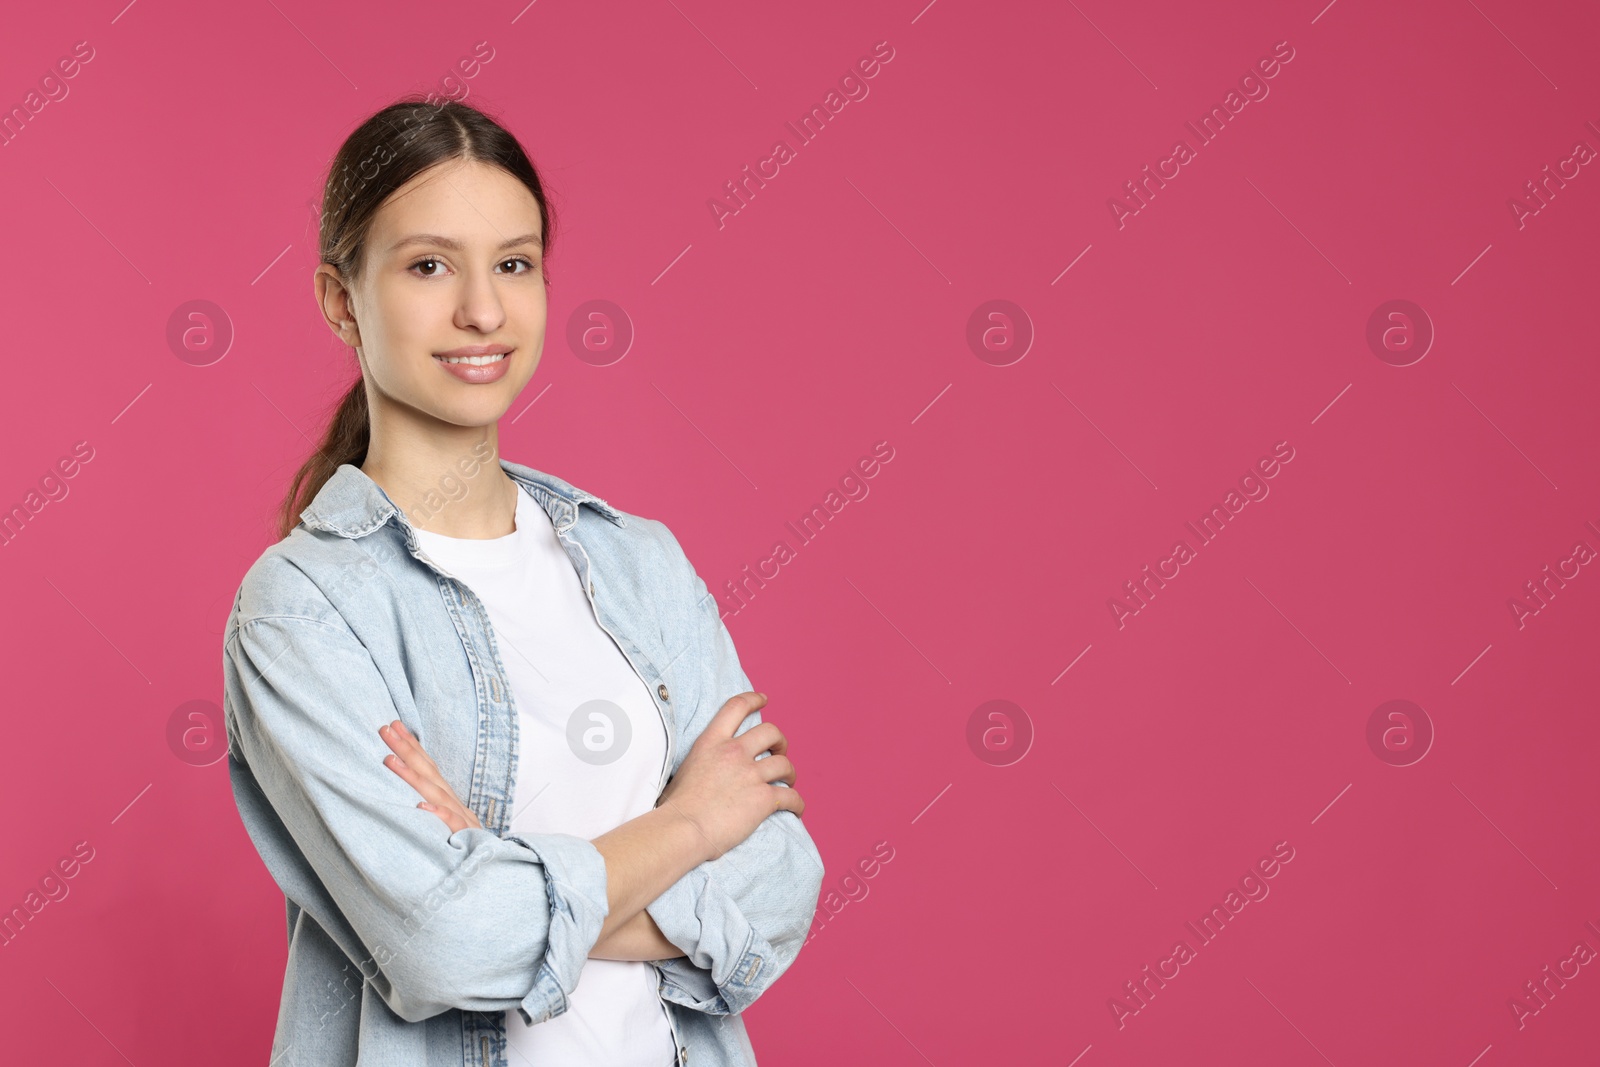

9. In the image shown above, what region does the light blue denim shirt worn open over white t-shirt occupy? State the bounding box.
[222,459,824,1067]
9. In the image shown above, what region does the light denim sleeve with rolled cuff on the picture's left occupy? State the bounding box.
[222,614,608,1025]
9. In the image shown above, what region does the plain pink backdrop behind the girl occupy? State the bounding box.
[0,0,1600,1067]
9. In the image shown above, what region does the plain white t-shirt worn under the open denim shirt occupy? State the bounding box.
[416,486,677,1067]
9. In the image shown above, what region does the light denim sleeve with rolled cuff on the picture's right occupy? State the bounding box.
[645,526,824,1014]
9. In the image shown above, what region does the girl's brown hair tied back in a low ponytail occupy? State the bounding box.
[277,99,554,539]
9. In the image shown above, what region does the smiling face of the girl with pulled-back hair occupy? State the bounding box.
[325,160,547,426]
